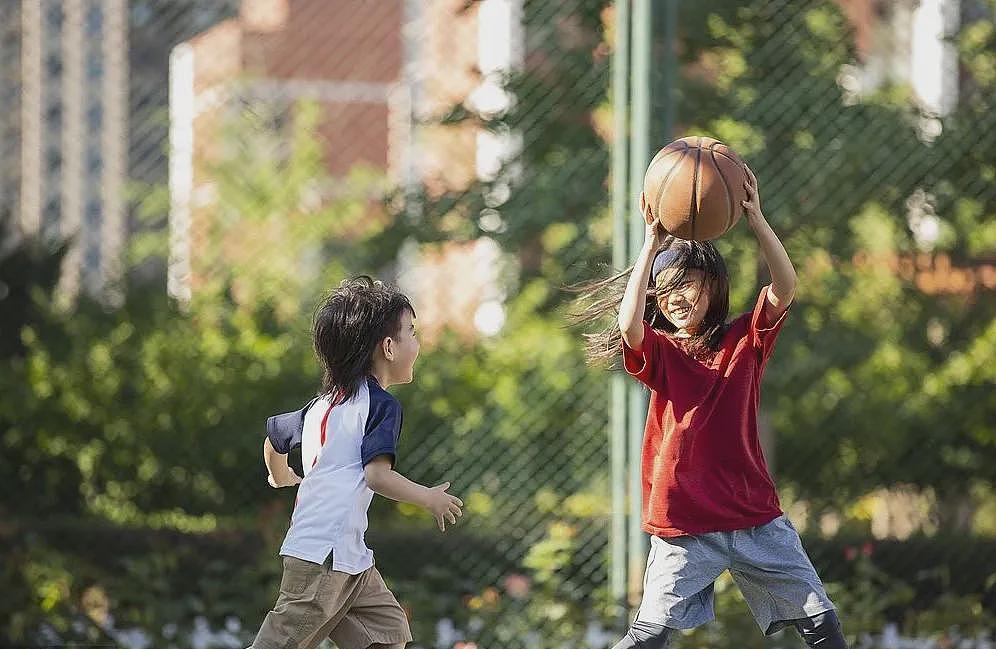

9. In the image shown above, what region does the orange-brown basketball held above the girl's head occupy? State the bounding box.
[643,136,747,241]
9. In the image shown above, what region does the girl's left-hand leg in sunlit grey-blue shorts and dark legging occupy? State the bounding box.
[615,534,729,649]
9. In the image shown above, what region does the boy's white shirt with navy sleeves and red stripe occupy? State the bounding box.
[266,377,401,575]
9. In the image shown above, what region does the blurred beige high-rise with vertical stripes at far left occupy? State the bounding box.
[0,0,128,296]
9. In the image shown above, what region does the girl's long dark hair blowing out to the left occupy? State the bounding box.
[570,236,730,365]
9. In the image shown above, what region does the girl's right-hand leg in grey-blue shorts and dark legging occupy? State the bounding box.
[730,515,844,649]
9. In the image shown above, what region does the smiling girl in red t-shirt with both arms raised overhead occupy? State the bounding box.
[581,169,846,649]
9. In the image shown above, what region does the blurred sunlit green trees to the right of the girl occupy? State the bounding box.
[676,2,996,514]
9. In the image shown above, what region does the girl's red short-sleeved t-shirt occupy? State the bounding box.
[623,287,788,537]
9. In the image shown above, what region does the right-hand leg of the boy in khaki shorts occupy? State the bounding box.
[327,568,412,649]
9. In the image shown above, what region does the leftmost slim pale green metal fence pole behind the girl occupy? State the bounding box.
[609,0,629,626]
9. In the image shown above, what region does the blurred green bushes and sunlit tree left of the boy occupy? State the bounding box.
[0,96,396,646]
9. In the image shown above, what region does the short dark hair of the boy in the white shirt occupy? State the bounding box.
[312,275,415,399]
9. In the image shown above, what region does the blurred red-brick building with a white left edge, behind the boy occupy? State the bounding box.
[167,0,404,300]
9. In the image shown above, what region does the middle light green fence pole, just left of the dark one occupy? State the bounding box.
[628,0,653,606]
